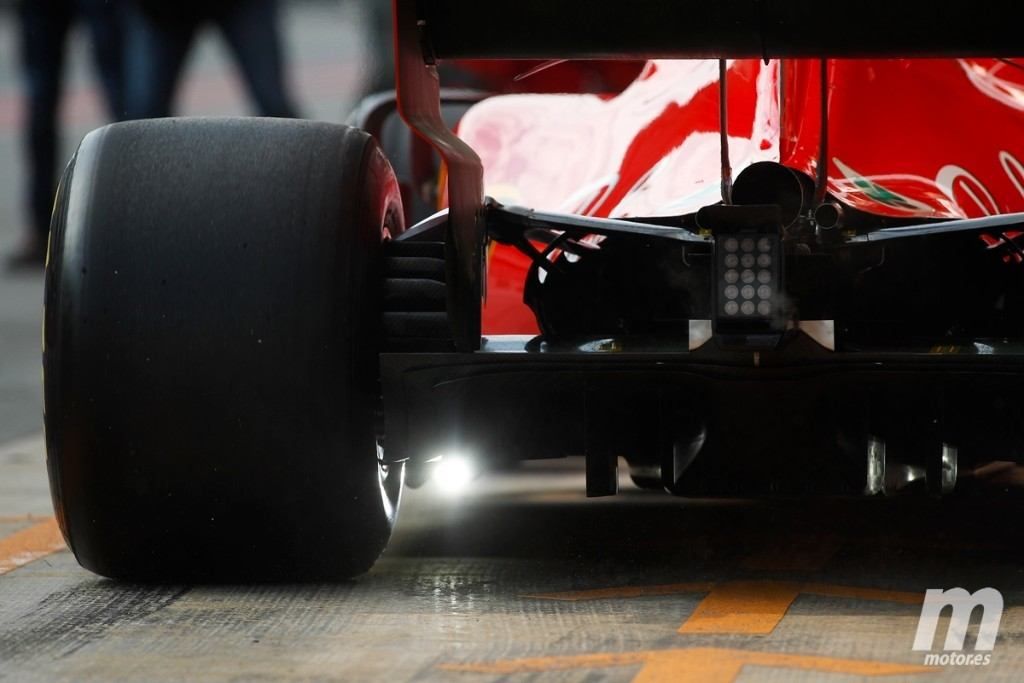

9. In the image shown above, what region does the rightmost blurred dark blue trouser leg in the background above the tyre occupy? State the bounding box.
[214,0,298,119]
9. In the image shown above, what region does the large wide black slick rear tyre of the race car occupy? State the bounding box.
[43,119,403,581]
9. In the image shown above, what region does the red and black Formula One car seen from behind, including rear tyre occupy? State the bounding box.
[44,0,1024,581]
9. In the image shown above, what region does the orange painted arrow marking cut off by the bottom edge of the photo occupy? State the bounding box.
[438,647,935,683]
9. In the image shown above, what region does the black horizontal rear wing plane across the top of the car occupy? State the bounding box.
[415,0,1024,59]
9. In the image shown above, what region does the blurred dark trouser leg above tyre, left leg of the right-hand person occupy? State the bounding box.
[123,0,200,119]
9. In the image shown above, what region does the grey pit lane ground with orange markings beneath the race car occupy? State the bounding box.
[0,437,1024,683]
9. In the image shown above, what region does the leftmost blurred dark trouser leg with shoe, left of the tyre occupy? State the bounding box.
[8,0,75,267]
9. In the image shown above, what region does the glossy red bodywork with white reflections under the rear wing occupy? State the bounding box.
[459,59,1024,335]
